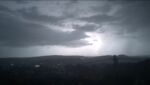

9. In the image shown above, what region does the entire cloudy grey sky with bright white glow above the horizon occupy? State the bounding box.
[0,0,150,57]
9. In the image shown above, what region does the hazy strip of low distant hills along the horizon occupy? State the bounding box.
[0,55,148,64]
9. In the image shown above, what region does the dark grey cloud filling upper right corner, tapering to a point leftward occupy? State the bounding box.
[80,0,150,37]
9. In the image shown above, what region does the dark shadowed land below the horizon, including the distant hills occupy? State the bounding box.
[0,56,150,85]
